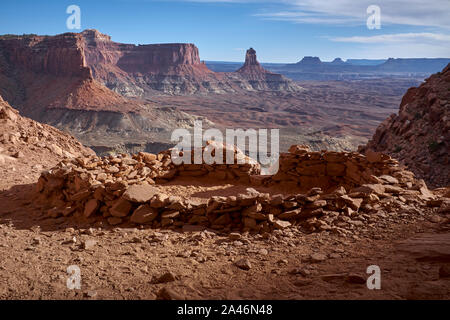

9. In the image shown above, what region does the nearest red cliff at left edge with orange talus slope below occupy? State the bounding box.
[0,33,137,120]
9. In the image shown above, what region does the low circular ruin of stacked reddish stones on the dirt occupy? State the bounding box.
[37,141,440,234]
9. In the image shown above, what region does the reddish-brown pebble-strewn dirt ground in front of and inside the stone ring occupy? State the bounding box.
[0,180,450,299]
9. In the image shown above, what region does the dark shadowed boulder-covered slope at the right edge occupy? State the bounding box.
[363,64,450,186]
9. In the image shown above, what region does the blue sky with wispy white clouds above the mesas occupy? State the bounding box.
[0,0,450,62]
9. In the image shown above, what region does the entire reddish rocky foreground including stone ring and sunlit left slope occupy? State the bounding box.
[0,78,450,299]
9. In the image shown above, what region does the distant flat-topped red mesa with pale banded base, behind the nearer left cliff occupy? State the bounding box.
[80,30,299,97]
